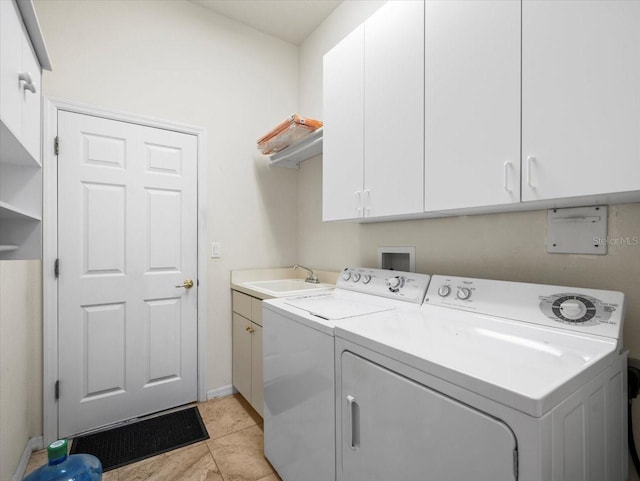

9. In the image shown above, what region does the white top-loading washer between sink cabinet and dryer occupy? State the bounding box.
[262,268,429,481]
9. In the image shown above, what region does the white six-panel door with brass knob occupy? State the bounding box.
[58,111,198,436]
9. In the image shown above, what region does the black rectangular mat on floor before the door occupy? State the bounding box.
[70,407,209,472]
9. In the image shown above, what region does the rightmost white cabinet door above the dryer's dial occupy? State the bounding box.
[522,0,640,201]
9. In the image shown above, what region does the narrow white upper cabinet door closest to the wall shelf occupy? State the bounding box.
[322,26,364,221]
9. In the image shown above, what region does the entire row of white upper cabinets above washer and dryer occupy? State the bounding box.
[323,0,640,221]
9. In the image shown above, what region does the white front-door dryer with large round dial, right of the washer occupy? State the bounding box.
[338,276,628,481]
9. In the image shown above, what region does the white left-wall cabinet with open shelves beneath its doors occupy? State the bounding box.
[0,0,50,259]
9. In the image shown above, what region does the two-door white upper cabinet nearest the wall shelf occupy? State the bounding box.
[323,0,424,220]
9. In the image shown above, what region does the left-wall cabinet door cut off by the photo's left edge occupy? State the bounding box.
[0,0,25,138]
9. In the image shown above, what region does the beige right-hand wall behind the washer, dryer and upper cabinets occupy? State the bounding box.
[298,1,640,479]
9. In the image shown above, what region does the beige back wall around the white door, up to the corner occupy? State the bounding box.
[35,0,298,402]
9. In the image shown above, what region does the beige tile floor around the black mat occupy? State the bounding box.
[25,394,281,481]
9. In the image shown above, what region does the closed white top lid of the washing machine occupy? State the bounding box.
[285,294,395,321]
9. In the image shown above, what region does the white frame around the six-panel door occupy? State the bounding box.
[42,97,207,446]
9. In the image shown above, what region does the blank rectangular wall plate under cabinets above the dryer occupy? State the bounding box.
[547,205,608,255]
